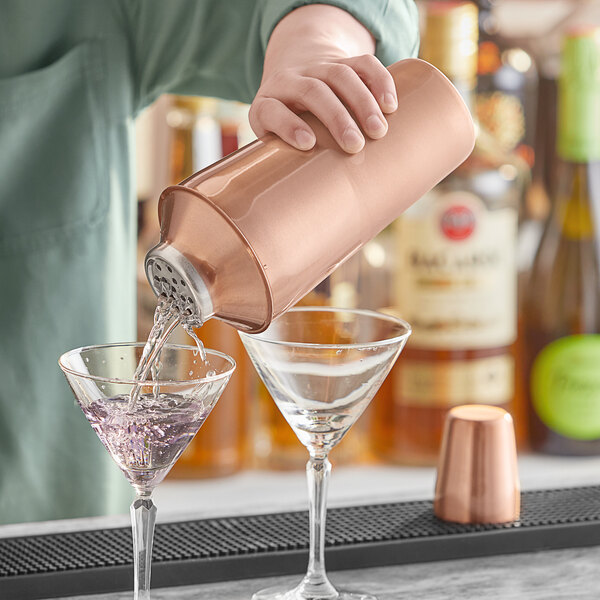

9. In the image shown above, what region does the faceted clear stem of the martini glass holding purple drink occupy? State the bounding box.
[130,493,156,600]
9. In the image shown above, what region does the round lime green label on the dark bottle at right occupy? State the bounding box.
[530,334,600,440]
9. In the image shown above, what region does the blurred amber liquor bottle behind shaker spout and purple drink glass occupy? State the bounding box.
[162,96,251,478]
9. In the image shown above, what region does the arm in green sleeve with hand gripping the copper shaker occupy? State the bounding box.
[119,0,418,152]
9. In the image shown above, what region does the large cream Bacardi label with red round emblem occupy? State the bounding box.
[394,191,517,349]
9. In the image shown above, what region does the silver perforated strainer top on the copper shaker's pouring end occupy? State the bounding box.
[145,243,213,327]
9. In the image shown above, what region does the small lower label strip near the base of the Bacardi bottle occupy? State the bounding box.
[395,354,515,408]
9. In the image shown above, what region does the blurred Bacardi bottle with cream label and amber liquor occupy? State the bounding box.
[371,2,523,464]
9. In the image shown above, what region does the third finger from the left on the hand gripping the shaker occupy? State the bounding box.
[313,63,388,139]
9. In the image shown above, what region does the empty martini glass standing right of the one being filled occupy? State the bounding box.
[240,307,410,600]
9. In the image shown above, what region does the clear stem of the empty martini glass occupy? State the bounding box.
[299,454,338,598]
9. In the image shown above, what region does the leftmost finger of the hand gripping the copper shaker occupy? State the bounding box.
[248,96,316,150]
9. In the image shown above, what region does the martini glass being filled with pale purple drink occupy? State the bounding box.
[59,343,235,600]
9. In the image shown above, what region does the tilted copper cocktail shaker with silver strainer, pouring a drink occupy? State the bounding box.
[146,59,475,333]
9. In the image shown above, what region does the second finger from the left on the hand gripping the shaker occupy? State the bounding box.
[277,77,365,154]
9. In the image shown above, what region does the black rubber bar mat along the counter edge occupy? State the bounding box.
[0,486,600,600]
